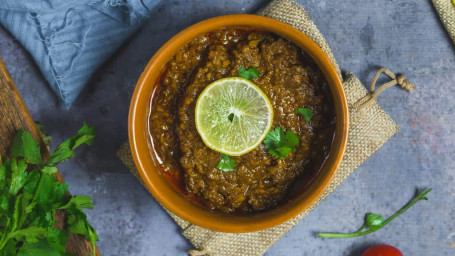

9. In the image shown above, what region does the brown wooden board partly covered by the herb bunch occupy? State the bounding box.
[0,58,101,256]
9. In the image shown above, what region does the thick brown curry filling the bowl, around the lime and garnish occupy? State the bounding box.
[149,28,335,214]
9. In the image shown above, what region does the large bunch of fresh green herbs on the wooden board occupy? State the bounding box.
[0,124,98,256]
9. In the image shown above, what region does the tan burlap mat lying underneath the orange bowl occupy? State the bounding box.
[117,0,416,256]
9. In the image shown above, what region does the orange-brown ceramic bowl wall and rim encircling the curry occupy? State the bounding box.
[128,14,349,233]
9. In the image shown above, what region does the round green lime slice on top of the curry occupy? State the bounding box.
[196,77,273,156]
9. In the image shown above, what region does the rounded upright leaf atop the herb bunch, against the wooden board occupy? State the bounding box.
[11,129,42,164]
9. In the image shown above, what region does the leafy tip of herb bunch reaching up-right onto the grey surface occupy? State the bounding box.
[46,123,96,166]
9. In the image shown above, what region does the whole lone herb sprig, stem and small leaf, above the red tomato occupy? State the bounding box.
[317,188,432,238]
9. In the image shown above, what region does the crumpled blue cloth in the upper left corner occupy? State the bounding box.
[0,0,161,109]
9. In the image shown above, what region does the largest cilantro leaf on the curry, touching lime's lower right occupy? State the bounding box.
[264,126,299,159]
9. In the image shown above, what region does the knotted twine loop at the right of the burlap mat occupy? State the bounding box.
[352,68,415,110]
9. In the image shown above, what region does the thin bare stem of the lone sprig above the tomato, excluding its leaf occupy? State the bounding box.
[317,188,432,238]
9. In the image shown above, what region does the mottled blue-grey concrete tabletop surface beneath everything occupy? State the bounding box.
[0,0,455,256]
